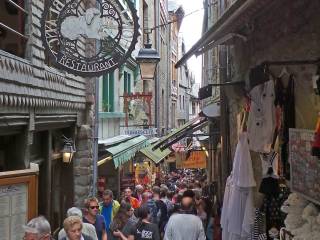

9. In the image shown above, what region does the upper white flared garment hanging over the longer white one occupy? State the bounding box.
[232,132,256,188]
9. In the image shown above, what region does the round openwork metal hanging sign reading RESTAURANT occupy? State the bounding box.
[41,0,139,76]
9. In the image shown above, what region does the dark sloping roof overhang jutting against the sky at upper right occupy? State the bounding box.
[175,0,277,68]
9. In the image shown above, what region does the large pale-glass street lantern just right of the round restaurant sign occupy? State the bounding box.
[136,33,160,80]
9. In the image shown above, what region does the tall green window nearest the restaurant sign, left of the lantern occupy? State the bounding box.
[102,72,114,112]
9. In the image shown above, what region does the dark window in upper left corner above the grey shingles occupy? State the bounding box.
[0,0,28,58]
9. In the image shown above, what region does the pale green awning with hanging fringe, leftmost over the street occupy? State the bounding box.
[106,136,150,168]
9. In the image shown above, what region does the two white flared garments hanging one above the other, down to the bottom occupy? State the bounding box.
[221,132,256,240]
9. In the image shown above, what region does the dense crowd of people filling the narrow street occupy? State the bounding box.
[24,171,213,240]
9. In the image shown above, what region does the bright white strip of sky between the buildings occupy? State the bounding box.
[177,0,203,83]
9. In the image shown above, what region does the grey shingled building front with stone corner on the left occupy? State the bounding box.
[0,0,95,230]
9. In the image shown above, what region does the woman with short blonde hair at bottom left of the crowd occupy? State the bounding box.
[62,216,93,240]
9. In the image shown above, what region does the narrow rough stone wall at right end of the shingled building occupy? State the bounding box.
[73,0,99,207]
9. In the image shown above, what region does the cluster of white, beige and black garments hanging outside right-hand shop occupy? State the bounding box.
[221,64,295,240]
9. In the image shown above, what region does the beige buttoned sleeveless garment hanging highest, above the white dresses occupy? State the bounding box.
[247,80,276,153]
